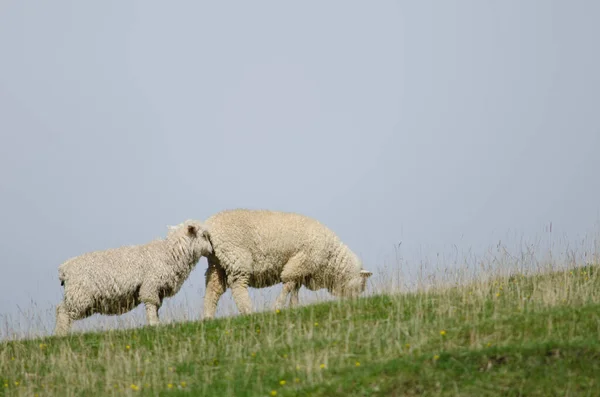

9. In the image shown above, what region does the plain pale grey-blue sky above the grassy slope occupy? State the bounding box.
[0,0,600,336]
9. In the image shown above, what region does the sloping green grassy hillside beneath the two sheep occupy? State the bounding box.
[0,267,600,396]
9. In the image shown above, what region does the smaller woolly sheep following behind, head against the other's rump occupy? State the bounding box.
[54,220,212,336]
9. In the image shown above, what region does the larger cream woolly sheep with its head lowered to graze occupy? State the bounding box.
[204,209,372,319]
